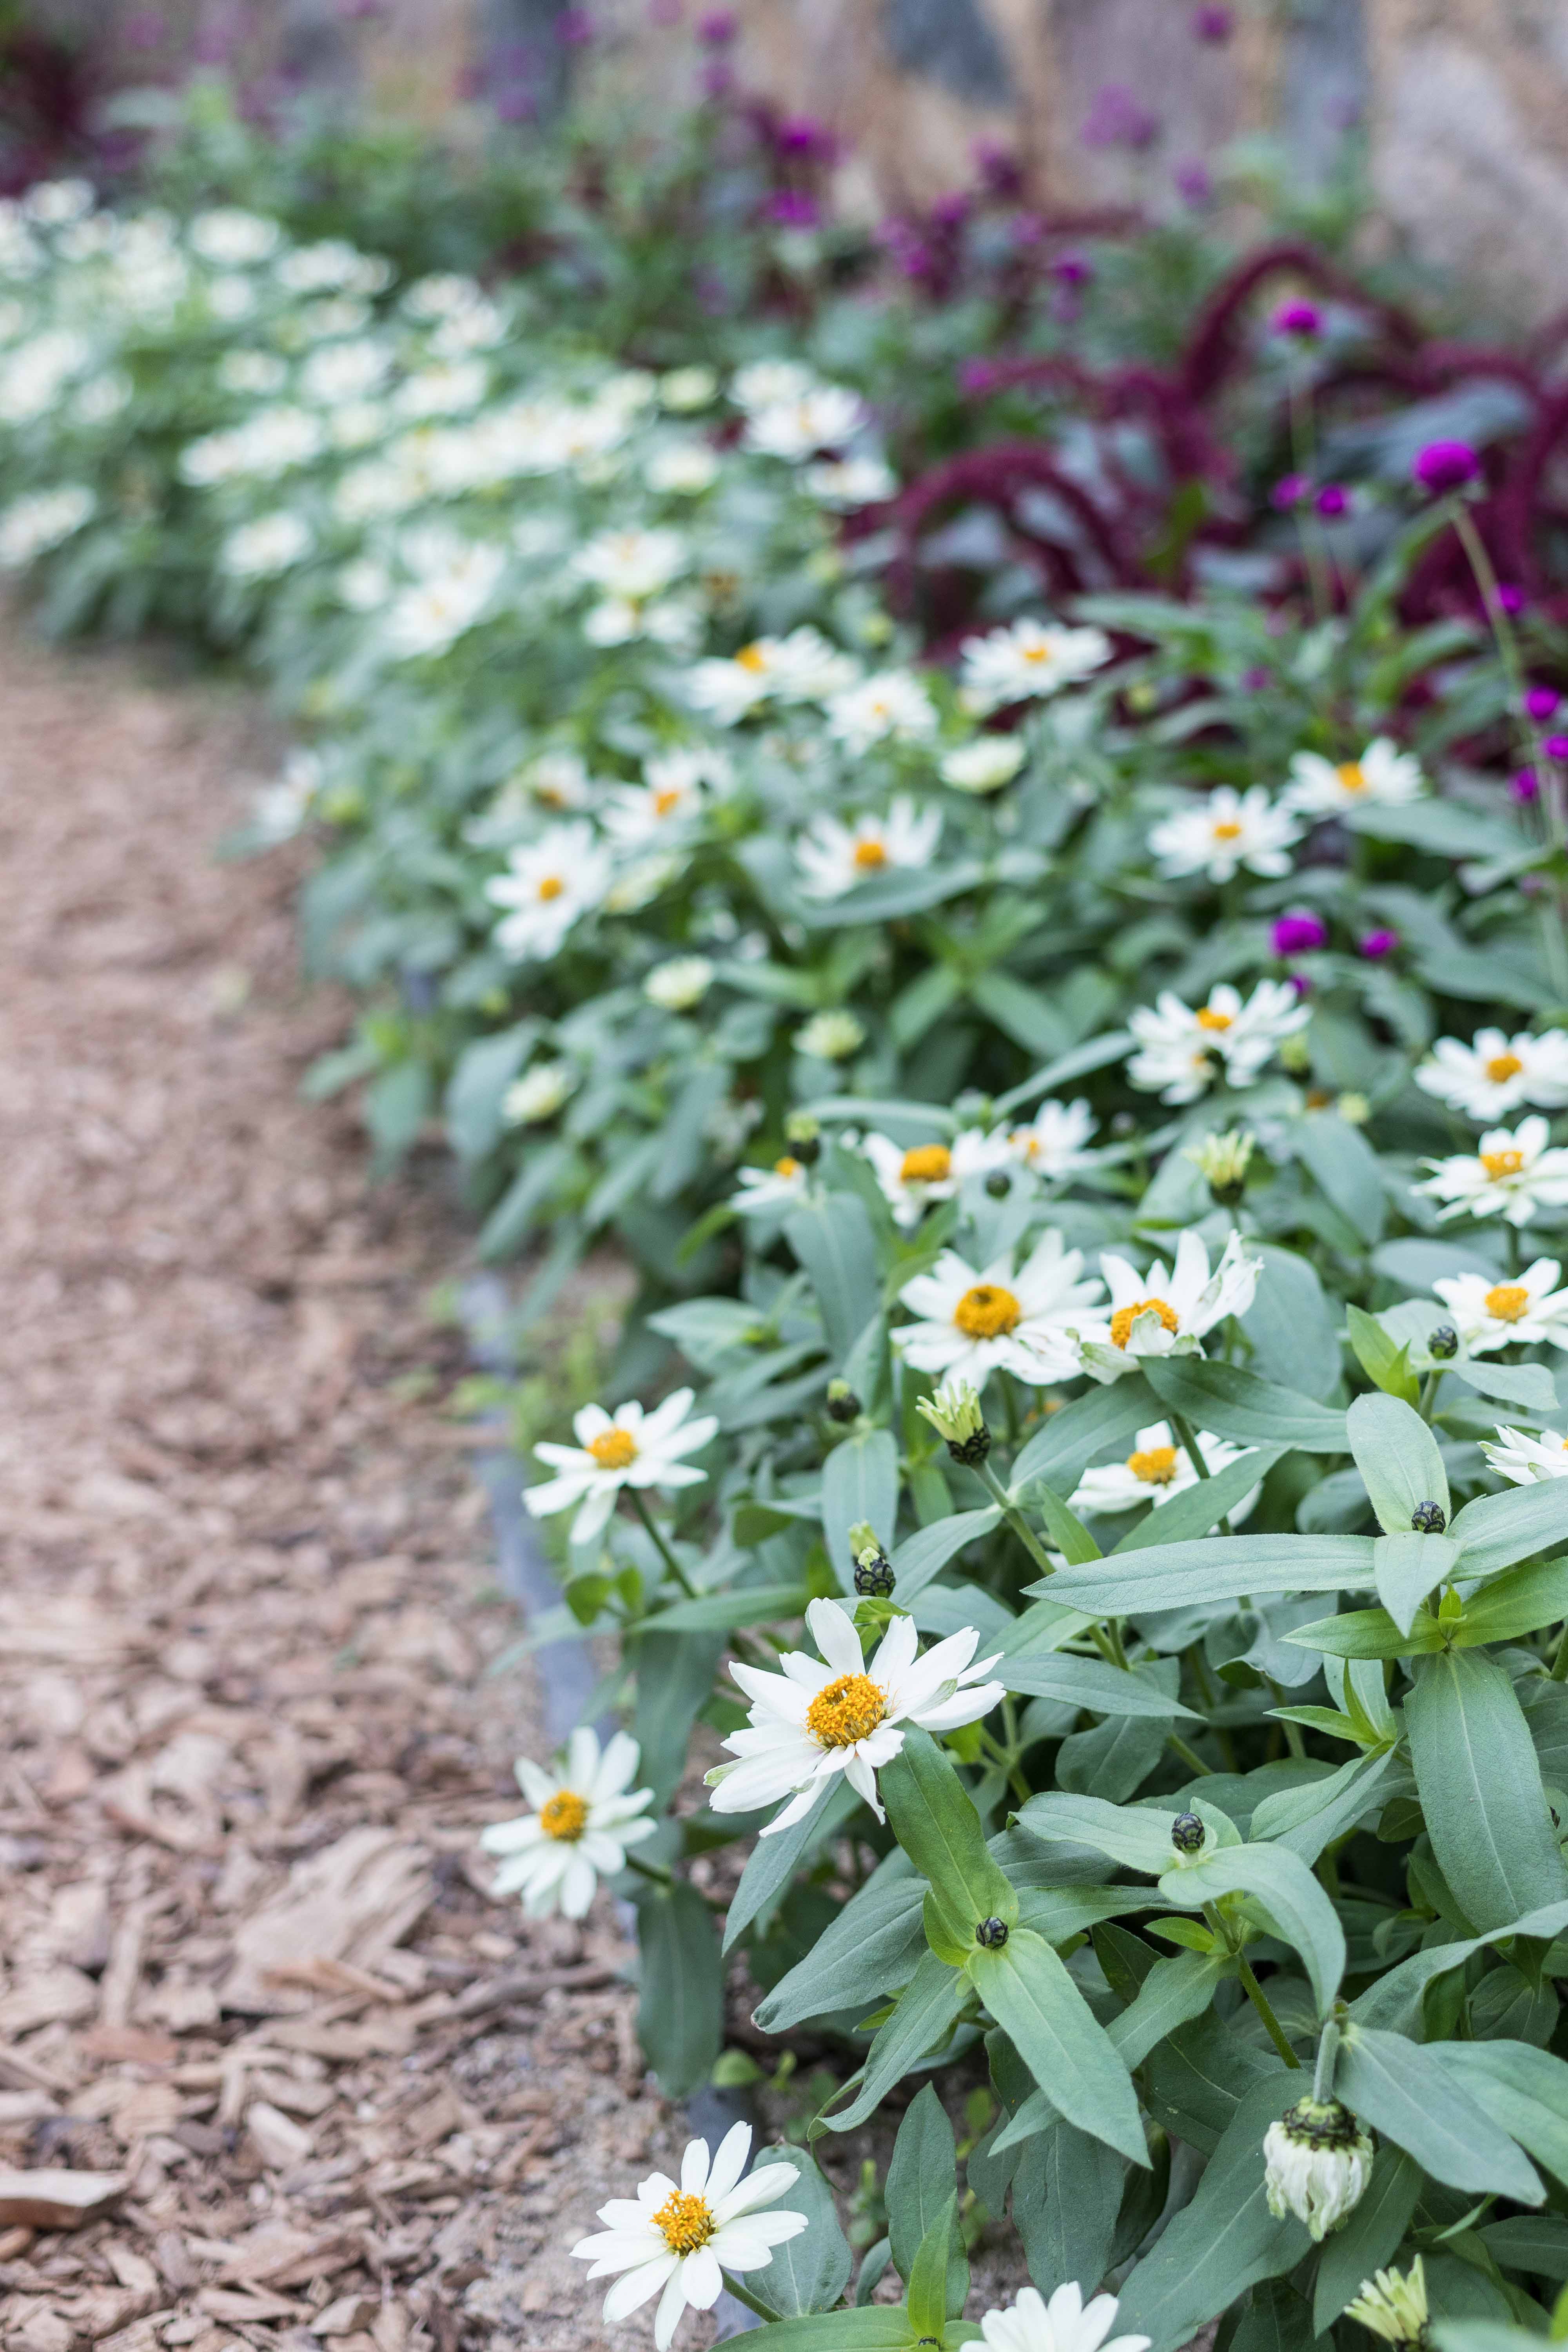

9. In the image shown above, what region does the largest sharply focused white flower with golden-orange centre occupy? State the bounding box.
[708,1602,1004,1837]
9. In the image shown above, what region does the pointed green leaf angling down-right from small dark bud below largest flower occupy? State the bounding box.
[969,1926,1150,2164]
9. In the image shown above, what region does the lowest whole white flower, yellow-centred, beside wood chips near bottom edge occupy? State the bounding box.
[571,2124,809,2352]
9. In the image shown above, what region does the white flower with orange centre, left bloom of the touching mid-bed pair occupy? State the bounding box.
[893,1230,1110,1390]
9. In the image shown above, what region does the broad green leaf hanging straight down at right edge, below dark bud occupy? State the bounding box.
[1406,1651,1568,1929]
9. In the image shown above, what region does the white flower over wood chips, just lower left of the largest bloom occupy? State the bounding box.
[479,1729,658,1919]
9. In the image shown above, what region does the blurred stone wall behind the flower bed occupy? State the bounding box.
[38,0,1568,322]
